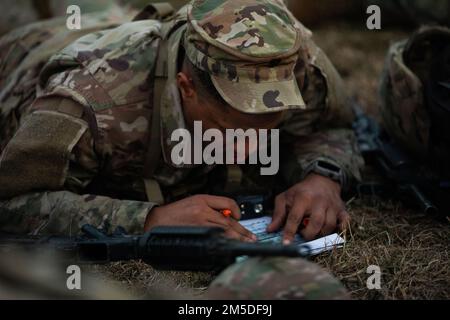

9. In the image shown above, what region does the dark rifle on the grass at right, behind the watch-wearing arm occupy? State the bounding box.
[353,103,450,219]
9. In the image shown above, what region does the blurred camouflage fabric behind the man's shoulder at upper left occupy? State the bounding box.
[0,6,137,152]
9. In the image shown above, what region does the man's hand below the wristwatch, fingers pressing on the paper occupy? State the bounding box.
[267,174,350,244]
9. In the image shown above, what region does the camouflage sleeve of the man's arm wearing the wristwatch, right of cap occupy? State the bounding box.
[281,41,363,190]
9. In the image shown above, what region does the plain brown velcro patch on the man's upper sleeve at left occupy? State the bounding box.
[0,111,88,199]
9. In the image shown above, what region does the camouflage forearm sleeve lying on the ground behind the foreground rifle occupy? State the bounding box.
[0,191,153,236]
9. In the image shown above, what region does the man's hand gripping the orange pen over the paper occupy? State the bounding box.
[144,195,257,242]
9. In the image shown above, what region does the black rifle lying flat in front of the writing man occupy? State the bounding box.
[0,225,310,271]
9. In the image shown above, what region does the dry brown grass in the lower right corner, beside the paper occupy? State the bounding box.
[314,199,450,299]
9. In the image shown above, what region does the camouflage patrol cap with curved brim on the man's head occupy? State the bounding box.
[184,0,305,113]
